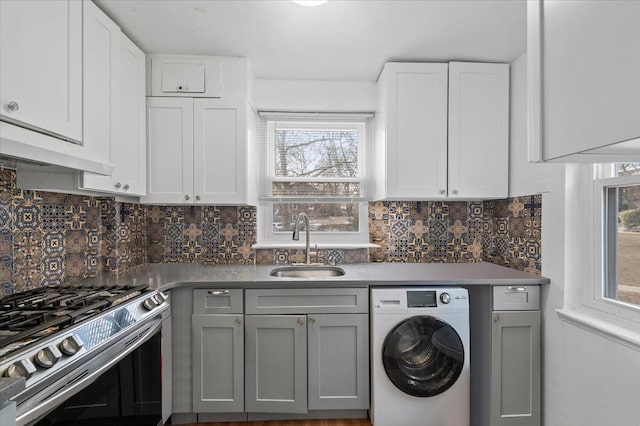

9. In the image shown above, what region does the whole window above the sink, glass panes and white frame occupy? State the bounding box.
[258,113,371,245]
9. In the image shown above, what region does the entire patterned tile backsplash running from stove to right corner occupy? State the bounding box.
[0,168,542,294]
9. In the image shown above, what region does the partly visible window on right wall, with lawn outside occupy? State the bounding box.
[594,163,640,312]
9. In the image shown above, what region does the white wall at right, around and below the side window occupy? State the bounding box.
[510,51,640,426]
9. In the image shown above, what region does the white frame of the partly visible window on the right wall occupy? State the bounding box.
[582,164,640,326]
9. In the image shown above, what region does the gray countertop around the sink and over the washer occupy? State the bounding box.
[72,262,549,290]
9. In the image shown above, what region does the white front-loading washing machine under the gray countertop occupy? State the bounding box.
[371,287,470,426]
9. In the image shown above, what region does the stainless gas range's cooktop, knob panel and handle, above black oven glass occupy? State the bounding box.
[0,285,169,425]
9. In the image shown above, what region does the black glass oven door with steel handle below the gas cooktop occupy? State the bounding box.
[16,309,168,426]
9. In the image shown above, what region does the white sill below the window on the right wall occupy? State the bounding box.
[556,309,640,351]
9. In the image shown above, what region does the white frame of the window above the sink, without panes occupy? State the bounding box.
[255,113,374,248]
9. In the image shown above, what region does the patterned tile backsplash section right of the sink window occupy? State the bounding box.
[369,195,542,274]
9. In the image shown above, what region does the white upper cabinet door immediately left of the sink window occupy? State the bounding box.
[193,99,248,204]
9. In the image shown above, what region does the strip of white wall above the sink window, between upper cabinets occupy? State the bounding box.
[252,79,376,112]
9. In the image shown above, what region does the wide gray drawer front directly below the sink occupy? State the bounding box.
[246,288,369,315]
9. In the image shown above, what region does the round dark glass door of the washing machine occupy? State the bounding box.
[382,316,464,397]
